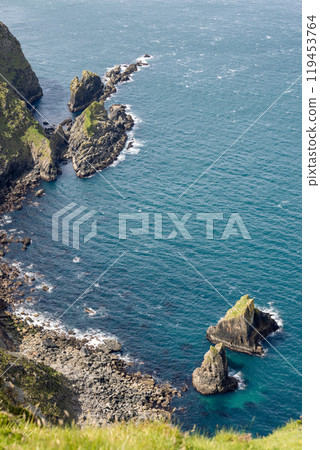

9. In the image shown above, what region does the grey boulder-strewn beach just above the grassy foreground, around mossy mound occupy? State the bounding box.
[0,221,176,426]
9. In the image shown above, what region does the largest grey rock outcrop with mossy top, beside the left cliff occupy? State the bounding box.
[69,102,133,178]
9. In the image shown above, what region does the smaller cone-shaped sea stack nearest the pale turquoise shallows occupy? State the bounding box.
[192,343,238,395]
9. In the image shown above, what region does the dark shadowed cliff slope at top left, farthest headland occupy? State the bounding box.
[0,22,42,102]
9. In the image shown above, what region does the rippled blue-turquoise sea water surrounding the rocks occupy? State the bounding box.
[1,0,301,434]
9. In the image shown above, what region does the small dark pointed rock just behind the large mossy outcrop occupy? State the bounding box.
[68,70,104,112]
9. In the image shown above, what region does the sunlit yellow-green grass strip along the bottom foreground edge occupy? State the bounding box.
[0,413,302,450]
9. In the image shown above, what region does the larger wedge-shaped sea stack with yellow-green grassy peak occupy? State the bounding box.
[207,295,279,355]
